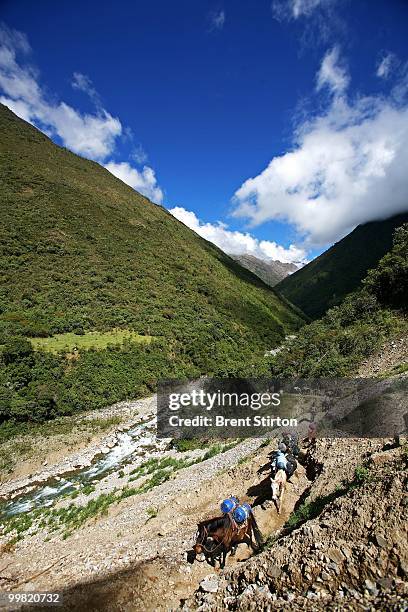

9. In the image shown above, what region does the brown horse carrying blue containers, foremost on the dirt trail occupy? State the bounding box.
[193,512,262,568]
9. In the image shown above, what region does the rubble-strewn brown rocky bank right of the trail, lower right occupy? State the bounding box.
[189,439,408,612]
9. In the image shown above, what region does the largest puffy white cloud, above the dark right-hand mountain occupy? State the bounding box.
[234,48,408,246]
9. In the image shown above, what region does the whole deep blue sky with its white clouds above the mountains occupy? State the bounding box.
[0,0,408,261]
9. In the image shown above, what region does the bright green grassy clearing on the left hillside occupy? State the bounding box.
[29,329,152,354]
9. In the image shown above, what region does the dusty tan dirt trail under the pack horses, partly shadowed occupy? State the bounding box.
[55,445,309,612]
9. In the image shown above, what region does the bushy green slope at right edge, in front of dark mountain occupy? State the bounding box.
[269,224,408,377]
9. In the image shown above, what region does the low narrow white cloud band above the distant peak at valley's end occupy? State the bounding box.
[170,206,306,264]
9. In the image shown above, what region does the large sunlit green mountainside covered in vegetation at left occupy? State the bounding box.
[0,105,302,426]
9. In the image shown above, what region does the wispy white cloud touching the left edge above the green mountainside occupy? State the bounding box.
[0,27,122,160]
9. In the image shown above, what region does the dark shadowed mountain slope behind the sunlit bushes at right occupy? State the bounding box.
[276,213,408,319]
